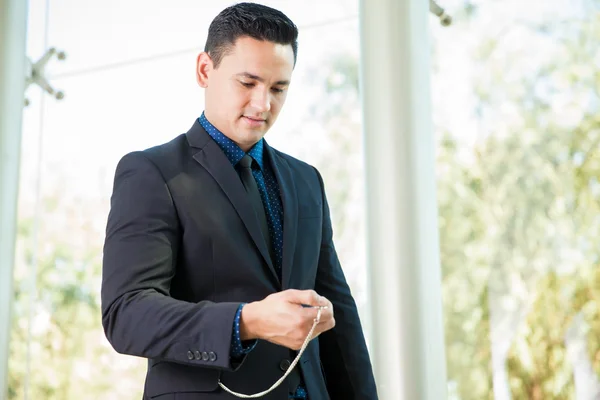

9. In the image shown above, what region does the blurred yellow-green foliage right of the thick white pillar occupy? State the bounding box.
[438,6,600,400]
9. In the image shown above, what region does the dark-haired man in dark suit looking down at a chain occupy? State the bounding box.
[102,3,377,400]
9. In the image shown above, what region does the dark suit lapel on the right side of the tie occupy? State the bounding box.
[265,143,298,290]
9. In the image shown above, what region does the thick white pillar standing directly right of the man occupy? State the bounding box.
[360,0,447,400]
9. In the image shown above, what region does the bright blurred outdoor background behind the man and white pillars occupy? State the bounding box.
[1,0,600,400]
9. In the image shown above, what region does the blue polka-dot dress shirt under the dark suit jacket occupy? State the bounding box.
[198,113,308,399]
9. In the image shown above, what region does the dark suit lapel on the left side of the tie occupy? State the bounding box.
[187,121,279,282]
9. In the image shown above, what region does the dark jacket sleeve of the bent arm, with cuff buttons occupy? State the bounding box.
[101,152,240,370]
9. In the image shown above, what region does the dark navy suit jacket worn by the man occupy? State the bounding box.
[102,121,377,400]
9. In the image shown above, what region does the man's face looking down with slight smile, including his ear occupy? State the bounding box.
[196,37,294,151]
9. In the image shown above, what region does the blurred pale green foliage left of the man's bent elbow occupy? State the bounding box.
[8,200,145,400]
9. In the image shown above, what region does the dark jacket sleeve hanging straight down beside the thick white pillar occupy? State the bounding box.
[315,167,378,400]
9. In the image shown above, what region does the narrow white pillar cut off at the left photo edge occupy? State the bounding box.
[0,0,28,399]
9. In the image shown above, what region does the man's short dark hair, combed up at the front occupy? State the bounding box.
[204,3,298,68]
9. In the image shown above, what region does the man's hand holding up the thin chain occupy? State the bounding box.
[240,289,335,350]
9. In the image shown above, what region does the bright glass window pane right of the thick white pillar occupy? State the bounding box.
[432,0,600,400]
